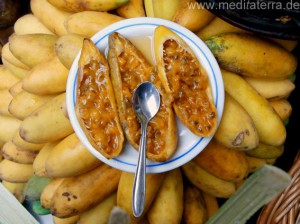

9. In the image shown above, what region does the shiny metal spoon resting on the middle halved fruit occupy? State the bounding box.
[132,82,160,217]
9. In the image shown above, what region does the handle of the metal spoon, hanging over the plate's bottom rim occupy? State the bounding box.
[132,122,148,217]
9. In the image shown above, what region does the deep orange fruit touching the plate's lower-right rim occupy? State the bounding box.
[193,140,248,183]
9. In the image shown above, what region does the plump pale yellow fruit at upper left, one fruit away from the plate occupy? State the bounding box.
[9,33,57,68]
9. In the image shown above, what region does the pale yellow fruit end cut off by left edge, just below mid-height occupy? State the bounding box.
[0,115,21,142]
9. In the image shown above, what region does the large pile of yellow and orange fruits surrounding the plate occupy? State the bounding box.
[0,0,297,224]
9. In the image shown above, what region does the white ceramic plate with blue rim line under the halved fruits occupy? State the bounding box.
[67,17,224,173]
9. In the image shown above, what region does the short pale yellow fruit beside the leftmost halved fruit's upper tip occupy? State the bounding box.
[55,34,84,69]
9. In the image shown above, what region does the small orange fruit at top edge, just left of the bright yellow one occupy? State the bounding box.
[116,0,146,18]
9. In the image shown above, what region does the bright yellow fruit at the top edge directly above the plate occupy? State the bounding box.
[144,0,181,20]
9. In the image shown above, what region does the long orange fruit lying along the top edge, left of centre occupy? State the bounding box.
[48,0,129,12]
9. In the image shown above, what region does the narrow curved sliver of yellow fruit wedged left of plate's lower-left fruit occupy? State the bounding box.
[33,141,58,177]
